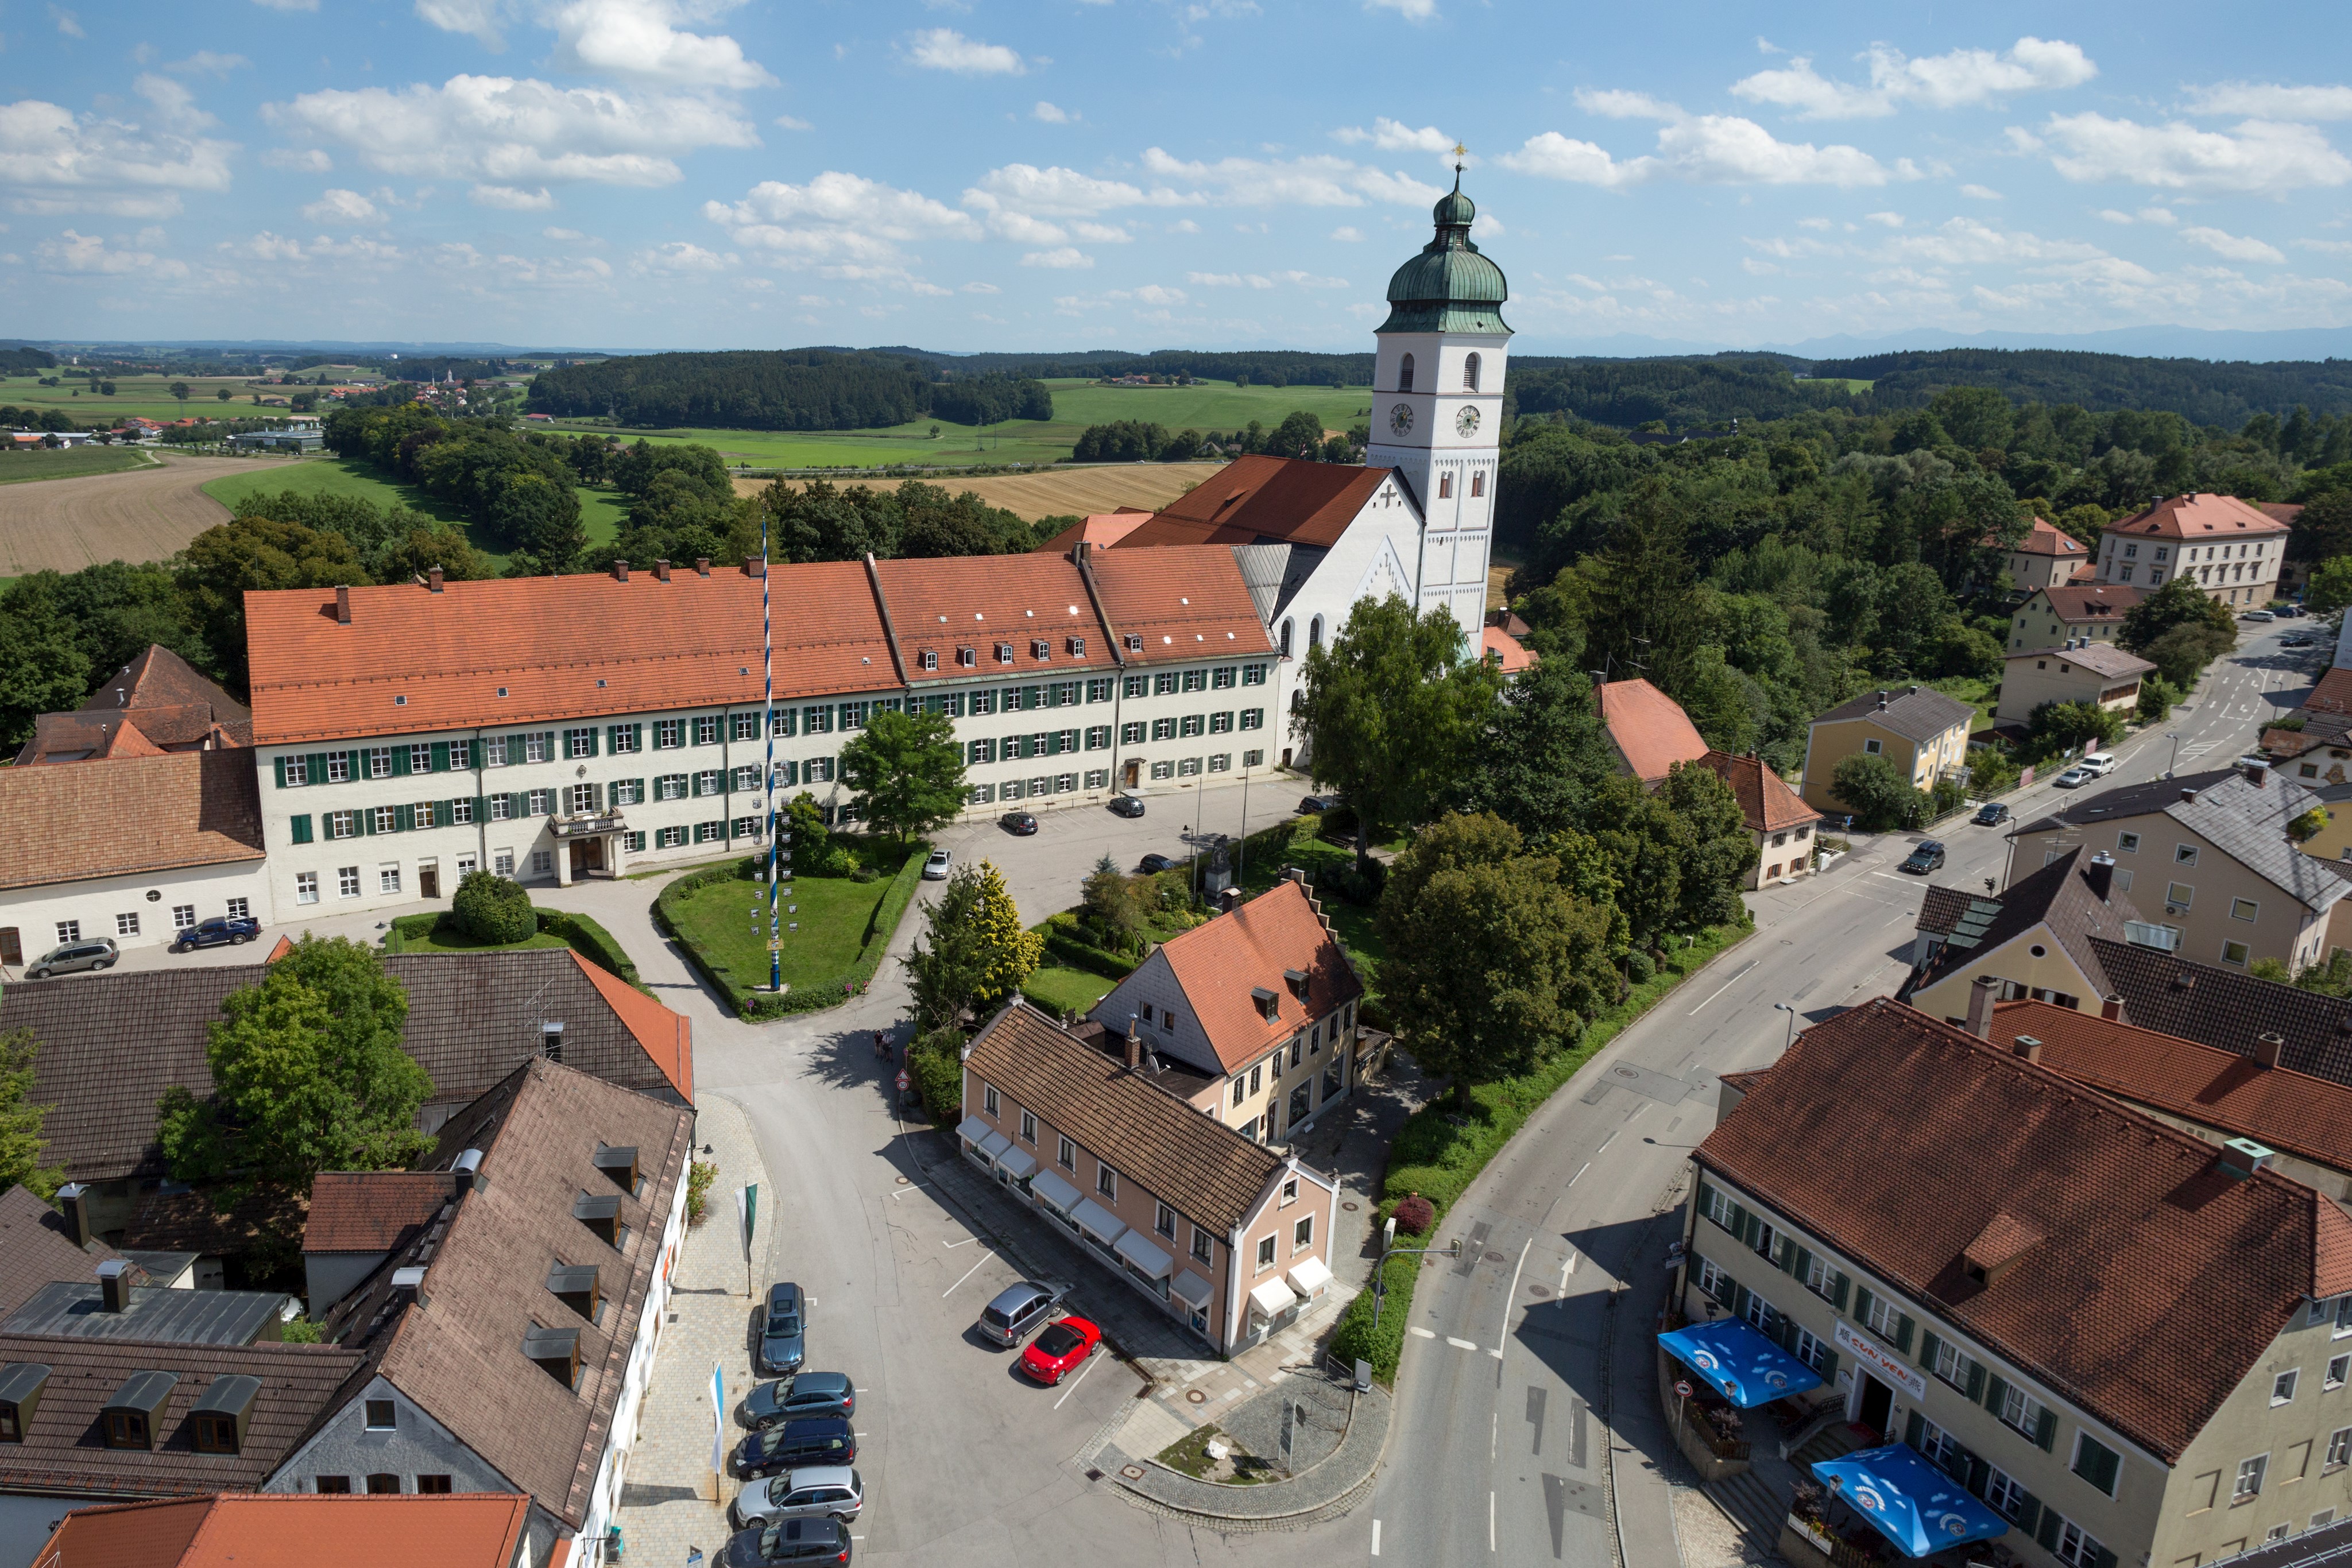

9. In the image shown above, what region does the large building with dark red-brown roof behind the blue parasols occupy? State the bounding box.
[1677,999,2352,1568]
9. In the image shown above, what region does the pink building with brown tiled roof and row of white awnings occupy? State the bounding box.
[957,1006,1339,1352]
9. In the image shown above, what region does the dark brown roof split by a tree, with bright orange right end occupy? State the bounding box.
[0,950,694,1183]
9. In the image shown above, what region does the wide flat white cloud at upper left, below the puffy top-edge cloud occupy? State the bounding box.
[264,75,757,185]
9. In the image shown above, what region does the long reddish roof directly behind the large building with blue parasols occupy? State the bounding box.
[1992,1001,2352,1171]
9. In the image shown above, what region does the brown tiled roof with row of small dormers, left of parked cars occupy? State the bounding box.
[322,1046,694,1528]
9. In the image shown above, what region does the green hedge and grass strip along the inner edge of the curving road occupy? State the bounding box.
[1331,924,1755,1383]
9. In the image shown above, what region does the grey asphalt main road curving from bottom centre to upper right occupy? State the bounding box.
[1374,621,2326,1568]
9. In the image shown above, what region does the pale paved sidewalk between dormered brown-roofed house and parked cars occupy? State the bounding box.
[614,1093,783,1563]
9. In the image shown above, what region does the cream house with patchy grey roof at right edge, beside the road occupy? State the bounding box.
[2009,764,2352,969]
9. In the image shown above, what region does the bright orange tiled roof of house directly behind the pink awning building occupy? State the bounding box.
[1134,879,1364,1072]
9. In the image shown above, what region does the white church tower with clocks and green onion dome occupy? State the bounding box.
[1364,165,1510,646]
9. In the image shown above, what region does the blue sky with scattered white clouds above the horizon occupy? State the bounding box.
[0,0,2352,353]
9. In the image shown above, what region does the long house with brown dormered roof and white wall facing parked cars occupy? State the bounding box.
[261,1058,694,1568]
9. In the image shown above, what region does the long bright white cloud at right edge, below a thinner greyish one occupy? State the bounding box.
[2041,113,2352,195]
